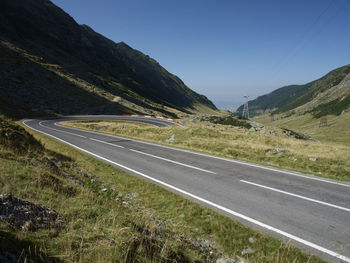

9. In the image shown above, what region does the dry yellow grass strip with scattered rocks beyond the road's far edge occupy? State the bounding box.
[64,121,350,183]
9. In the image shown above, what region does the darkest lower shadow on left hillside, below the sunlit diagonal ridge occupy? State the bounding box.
[0,42,138,118]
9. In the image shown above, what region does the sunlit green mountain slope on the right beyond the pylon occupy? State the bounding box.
[237,65,350,117]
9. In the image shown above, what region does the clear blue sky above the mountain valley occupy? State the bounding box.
[53,0,350,107]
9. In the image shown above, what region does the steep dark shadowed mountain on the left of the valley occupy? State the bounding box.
[0,0,216,116]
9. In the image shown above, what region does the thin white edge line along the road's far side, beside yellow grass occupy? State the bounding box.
[56,120,350,187]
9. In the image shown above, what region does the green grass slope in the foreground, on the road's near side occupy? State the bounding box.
[0,118,321,262]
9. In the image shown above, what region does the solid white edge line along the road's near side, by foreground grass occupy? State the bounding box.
[22,121,350,263]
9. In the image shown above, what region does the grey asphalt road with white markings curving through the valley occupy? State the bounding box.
[24,116,350,262]
